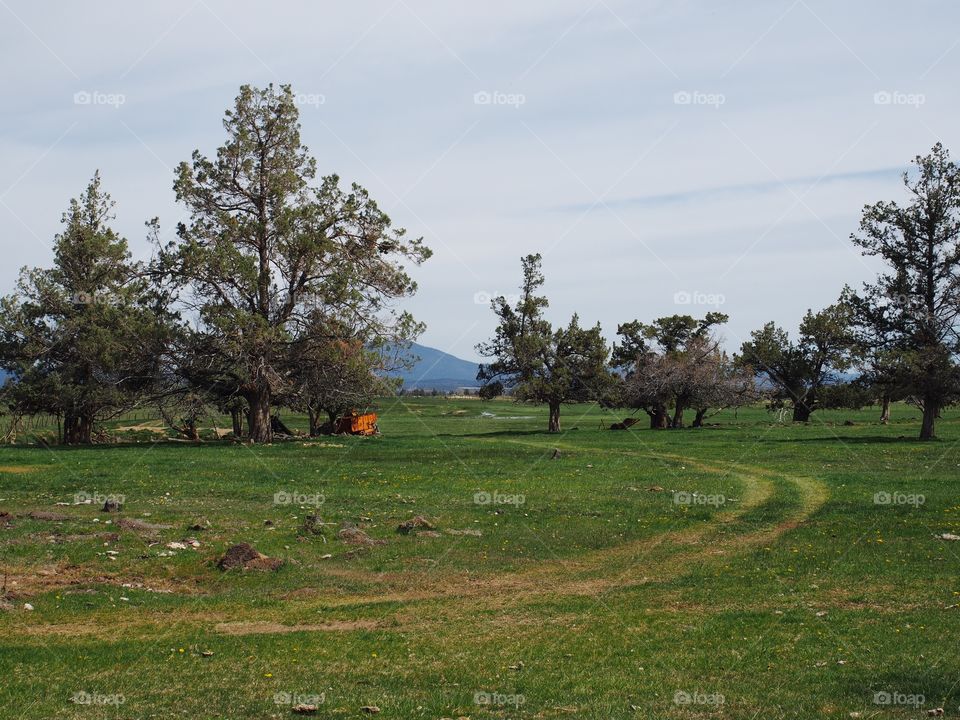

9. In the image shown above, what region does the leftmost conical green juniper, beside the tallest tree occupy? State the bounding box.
[0,173,172,443]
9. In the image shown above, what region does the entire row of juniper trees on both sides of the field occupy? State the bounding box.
[0,85,960,444]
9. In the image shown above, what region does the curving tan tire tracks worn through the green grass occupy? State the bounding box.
[7,441,829,635]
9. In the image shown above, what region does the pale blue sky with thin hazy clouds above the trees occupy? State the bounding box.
[0,0,960,360]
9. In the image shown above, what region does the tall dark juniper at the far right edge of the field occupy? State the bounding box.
[851,143,960,440]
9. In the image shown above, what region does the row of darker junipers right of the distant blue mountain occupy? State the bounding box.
[477,143,960,440]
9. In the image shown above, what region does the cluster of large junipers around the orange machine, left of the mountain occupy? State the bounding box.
[0,85,430,444]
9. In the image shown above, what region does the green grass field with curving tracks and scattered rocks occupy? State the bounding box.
[0,398,960,720]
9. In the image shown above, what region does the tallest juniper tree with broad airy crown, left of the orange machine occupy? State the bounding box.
[159,85,430,442]
